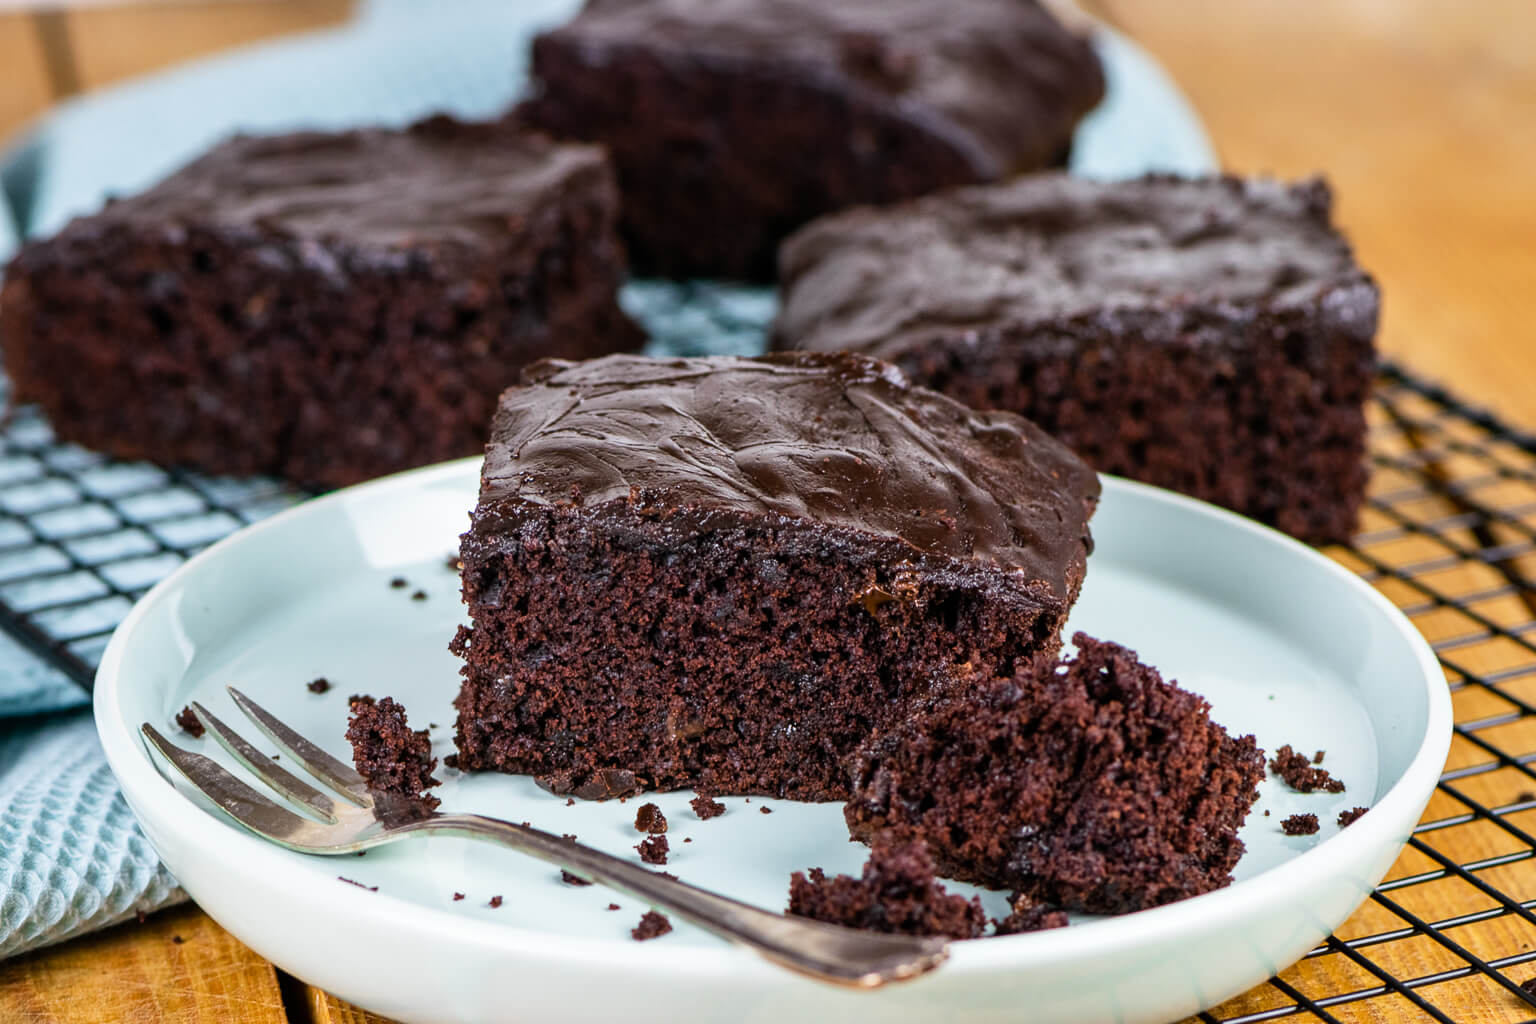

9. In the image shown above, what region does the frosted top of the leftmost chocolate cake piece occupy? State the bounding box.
[54,117,607,247]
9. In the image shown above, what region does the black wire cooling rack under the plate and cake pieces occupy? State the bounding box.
[0,354,1536,1024]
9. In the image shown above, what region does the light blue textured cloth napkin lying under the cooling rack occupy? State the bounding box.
[0,0,1213,956]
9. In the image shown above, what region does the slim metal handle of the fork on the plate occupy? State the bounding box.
[401,814,949,989]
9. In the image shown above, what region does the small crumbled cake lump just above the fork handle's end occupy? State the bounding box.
[788,843,986,938]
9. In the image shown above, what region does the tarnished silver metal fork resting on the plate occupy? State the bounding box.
[143,686,949,989]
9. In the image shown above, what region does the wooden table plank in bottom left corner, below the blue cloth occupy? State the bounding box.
[0,907,287,1024]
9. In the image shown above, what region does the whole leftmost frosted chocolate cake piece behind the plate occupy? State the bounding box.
[0,118,641,487]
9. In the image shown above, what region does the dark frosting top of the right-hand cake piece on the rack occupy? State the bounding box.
[777,173,1364,355]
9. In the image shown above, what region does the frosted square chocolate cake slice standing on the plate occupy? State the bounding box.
[455,353,1098,800]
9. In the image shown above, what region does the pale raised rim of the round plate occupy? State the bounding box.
[94,457,1452,978]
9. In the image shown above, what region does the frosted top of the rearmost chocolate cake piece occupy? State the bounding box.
[534,0,1104,177]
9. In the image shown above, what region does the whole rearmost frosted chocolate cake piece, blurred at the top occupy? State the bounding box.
[521,0,1104,281]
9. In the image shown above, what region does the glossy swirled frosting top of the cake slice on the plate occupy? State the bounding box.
[481,353,1098,596]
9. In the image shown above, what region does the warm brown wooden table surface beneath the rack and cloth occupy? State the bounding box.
[0,0,1536,1024]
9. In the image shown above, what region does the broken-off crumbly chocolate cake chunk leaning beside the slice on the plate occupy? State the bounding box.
[843,633,1264,913]
